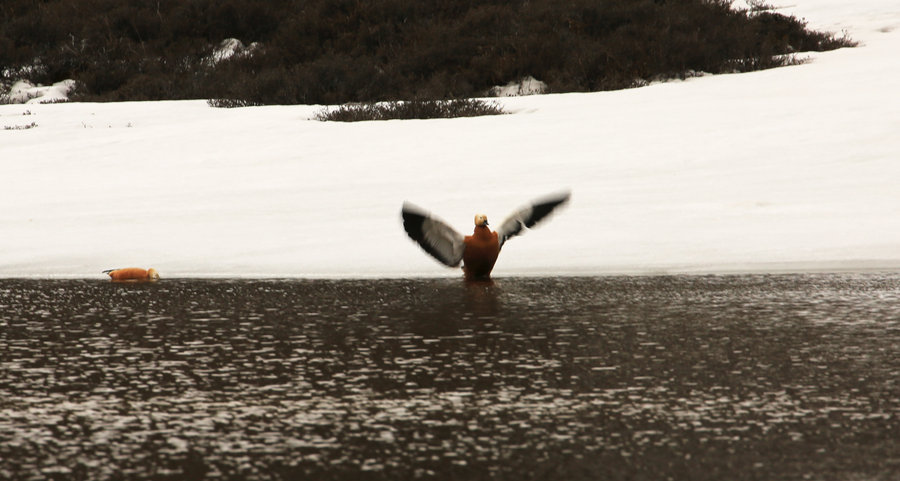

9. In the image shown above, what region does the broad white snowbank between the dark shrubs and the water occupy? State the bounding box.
[0,0,900,279]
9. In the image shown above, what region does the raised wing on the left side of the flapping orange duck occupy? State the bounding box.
[401,202,466,267]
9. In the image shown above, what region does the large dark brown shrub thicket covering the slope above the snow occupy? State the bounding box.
[0,0,852,104]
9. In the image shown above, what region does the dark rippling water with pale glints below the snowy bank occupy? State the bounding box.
[0,275,900,480]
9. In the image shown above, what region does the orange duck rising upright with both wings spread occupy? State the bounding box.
[401,192,571,280]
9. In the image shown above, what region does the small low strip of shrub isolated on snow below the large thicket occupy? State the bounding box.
[316,99,505,122]
